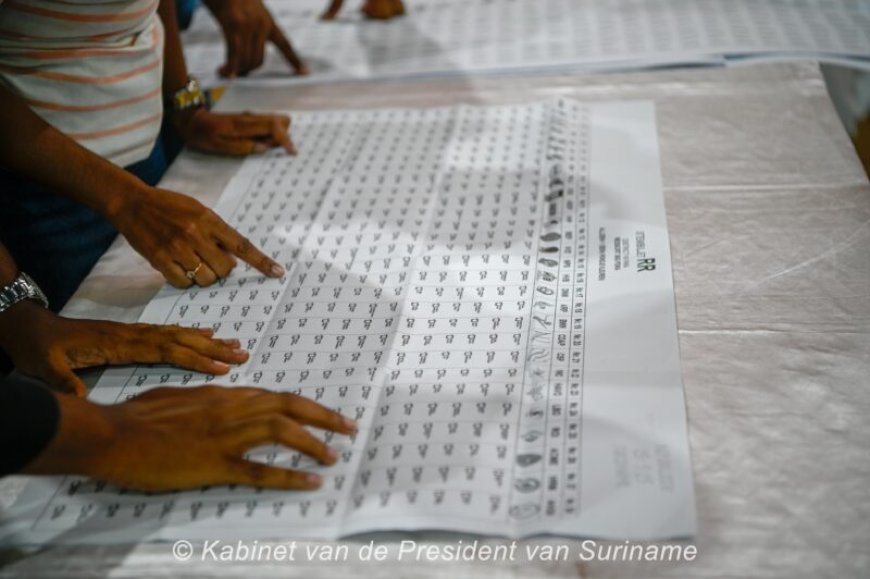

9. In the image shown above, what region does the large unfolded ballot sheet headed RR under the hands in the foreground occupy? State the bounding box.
[0,99,695,542]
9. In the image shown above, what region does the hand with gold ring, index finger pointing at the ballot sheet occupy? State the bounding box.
[109,187,284,288]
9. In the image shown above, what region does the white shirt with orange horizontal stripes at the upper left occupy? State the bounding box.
[0,0,163,167]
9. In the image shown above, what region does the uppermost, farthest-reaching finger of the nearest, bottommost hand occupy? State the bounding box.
[232,391,357,434]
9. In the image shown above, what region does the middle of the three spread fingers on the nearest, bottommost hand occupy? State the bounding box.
[226,414,338,464]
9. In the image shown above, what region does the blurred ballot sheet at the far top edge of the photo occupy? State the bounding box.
[184,0,870,83]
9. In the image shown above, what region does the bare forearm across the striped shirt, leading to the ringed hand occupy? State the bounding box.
[0,86,146,217]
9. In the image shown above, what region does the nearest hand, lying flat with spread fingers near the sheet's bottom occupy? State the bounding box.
[25,386,356,491]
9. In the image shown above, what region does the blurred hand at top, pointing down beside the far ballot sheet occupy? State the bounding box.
[205,0,308,78]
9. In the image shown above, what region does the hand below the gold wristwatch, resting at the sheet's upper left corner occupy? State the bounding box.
[173,108,296,156]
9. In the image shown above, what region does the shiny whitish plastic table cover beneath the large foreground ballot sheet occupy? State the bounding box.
[0,63,870,579]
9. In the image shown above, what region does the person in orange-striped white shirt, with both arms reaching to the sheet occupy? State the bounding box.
[0,0,295,309]
